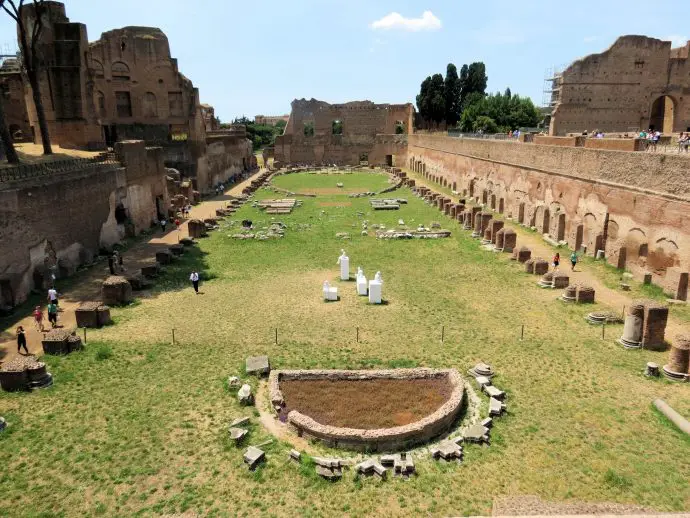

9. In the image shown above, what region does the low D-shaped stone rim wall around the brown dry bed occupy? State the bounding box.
[268,368,464,451]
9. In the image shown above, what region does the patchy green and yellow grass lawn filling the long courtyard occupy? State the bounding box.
[0,174,690,516]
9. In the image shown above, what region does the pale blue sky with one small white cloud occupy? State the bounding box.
[0,0,690,121]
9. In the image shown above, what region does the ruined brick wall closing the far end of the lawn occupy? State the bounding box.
[275,99,413,164]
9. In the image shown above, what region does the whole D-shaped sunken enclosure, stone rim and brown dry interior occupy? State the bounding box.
[269,368,464,452]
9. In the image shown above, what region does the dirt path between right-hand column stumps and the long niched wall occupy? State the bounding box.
[403,169,684,337]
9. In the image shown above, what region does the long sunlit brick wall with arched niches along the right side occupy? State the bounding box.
[406,135,690,296]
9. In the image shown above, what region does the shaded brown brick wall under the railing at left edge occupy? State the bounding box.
[0,165,123,305]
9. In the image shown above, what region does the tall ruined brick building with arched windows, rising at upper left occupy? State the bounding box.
[0,1,253,192]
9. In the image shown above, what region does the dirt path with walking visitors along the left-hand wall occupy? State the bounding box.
[0,170,262,362]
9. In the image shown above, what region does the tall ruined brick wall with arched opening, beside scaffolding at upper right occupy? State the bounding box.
[550,36,690,135]
